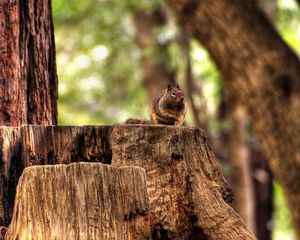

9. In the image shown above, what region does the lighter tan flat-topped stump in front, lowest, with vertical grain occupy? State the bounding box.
[5,163,150,240]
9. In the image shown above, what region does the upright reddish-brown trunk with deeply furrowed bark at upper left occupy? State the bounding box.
[0,0,57,126]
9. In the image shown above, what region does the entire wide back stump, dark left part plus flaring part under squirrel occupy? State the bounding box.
[1,125,256,240]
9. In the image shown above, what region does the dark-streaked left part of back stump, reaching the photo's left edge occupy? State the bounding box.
[0,126,111,226]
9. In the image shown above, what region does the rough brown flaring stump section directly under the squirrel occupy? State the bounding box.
[111,125,255,240]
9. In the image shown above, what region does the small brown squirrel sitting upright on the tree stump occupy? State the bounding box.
[151,85,187,126]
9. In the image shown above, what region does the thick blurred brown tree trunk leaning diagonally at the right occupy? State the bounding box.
[169,0,300,236]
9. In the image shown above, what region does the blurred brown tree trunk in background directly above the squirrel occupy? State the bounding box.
[133,7,176,103]
